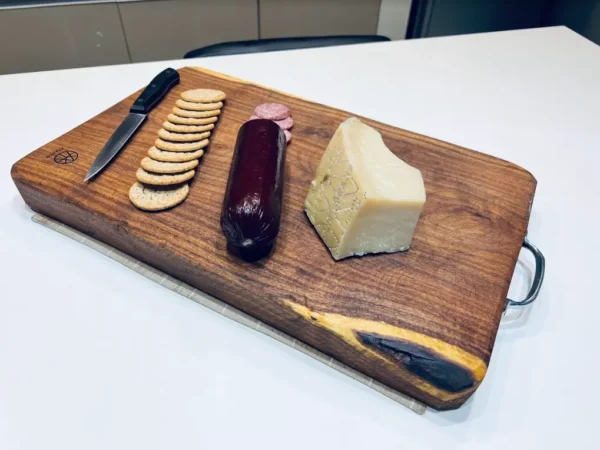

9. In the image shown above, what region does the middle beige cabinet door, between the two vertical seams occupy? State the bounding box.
[119,0,258,62]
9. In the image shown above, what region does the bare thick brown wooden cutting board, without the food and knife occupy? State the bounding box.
[12,68,536,409]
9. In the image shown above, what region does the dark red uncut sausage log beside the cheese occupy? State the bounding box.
[221,119,286,261]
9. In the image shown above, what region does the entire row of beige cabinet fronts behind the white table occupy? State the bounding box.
[0,0,390,74]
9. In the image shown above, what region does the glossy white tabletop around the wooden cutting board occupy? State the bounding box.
[0,28,600,450]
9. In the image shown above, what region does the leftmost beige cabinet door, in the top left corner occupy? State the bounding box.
[0,3,129,74]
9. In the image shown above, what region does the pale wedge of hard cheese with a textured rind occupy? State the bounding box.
[304,117,425,259]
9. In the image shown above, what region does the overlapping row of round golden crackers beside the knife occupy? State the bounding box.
[129,89,225,211]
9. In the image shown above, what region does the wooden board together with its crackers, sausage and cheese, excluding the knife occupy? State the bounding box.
[12,68,536,409]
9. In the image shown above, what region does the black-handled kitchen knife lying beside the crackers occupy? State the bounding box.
[83,68,179,181]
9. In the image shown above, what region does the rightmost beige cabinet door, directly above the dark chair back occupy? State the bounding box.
[259,0,380,38]
